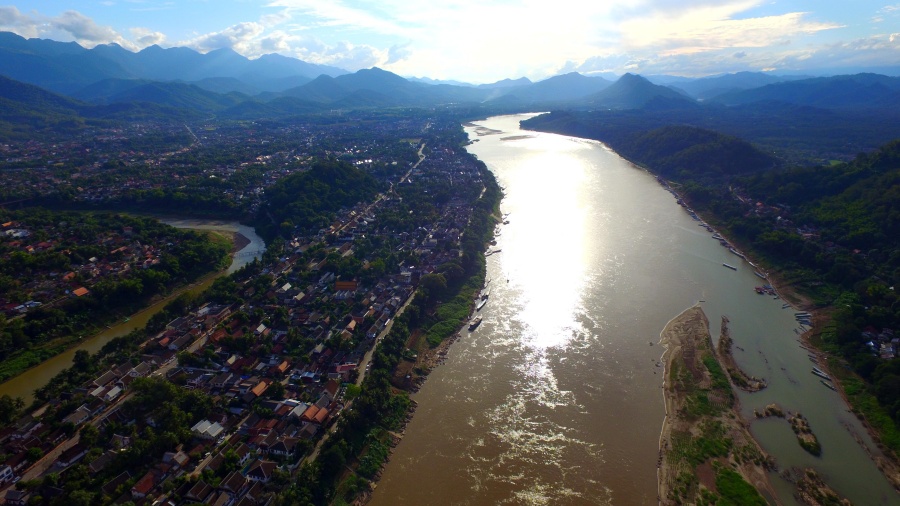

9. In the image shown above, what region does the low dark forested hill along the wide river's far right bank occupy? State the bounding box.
[522,113,779,181]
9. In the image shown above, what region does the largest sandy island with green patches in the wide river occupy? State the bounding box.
[657,305,776,505]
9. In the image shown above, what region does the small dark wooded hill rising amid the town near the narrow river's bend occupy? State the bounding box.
[256,160,383,241]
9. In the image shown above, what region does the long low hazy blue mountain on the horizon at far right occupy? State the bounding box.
[714,74,900,110]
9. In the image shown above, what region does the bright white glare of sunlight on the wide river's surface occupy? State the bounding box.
[502,140,591,349]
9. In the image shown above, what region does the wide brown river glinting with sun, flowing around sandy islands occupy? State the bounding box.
[371,115,898,506]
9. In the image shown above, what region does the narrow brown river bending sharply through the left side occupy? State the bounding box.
[0,218,266,405]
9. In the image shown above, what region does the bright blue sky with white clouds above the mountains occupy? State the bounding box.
[0,0,900,83]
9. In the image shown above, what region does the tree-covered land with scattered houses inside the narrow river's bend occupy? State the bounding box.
[0,208,231,379]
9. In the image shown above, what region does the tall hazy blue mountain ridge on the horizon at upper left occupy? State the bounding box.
[0,32,347,93]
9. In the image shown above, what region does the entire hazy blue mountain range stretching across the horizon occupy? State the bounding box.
[0,32,900,118]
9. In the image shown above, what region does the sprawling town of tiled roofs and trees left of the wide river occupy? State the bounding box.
[0,111,499,506]
